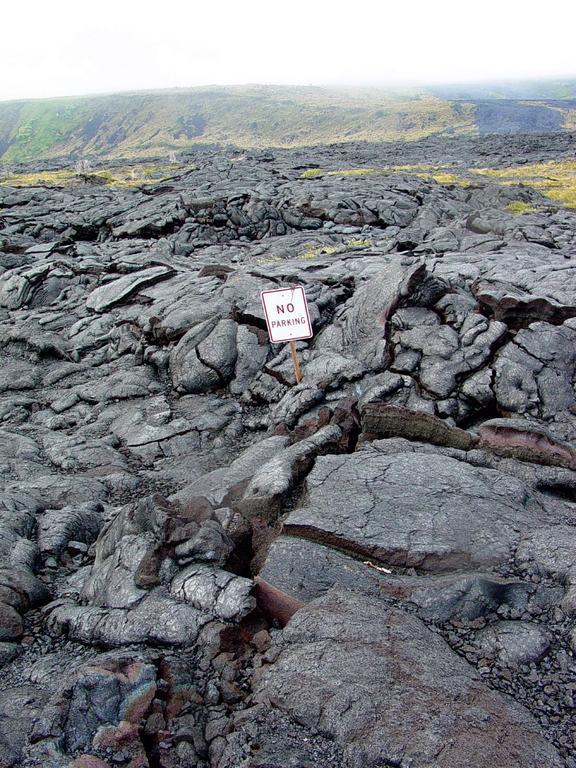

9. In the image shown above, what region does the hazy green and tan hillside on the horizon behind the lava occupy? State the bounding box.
[0,81,576,163]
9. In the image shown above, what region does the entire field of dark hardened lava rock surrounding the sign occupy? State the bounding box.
[0,136,576,768]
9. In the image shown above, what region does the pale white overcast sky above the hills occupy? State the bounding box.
[0,0,576,100]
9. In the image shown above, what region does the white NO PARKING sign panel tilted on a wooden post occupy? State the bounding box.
[260,285,312,344]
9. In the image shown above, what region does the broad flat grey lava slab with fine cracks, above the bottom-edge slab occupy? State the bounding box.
[284,440,570,573]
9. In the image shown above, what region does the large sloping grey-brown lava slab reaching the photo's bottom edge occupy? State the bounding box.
[234,590,562,768]
